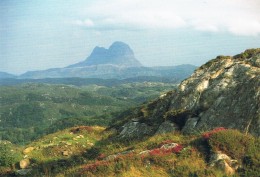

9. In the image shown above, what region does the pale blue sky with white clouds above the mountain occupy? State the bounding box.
[0,0,260,74]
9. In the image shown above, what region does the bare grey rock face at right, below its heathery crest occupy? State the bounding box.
[170,52,260,136]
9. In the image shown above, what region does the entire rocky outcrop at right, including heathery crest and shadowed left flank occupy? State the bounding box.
[115,49,260,136]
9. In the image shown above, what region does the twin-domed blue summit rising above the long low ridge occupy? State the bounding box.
[68,41,142,68]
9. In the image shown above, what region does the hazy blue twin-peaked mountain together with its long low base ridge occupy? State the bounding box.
[19,42,196,81]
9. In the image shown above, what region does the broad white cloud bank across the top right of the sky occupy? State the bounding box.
[72,0,260,36]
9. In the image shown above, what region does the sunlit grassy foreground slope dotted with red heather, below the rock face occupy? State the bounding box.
[1,126,260,177]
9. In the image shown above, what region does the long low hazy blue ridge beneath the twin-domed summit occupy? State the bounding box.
[19,65,196,81]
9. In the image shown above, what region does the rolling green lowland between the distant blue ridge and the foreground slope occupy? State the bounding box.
[0,82,175,144]
